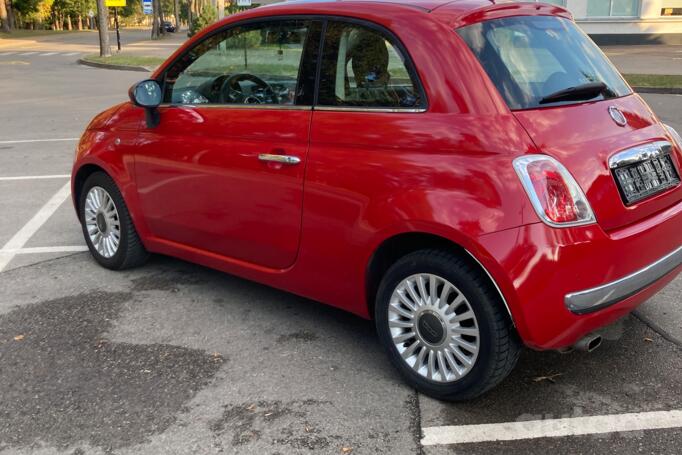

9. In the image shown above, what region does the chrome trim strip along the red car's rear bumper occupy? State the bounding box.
[564,247,682,314]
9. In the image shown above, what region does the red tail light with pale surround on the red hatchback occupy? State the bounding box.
[514,155,596,227]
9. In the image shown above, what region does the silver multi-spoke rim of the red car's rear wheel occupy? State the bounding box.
[388,273,480,382]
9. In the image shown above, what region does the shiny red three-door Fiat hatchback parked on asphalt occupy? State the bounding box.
[72,0,682,400]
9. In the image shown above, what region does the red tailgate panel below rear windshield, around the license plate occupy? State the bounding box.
[515,95,682,231]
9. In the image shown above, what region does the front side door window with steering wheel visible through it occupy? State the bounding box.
[164,20,311,105]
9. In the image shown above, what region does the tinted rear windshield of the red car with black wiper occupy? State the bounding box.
[457,16,630,110]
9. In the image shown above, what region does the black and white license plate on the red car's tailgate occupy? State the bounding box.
[613,146,680,205]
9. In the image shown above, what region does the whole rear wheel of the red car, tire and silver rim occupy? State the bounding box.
[375,250,520,401]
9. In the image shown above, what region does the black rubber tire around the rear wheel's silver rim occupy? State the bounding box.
[375,250,521,401]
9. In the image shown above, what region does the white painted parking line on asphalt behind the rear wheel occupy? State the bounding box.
[422,410,682,446]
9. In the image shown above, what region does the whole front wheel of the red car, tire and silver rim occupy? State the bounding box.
[79,172,148,270]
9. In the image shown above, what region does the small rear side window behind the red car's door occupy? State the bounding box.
[319,22,424,108]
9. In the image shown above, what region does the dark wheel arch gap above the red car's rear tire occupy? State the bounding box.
[365,232,515,325]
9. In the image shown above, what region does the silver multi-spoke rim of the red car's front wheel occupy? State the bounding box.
[85,186,121,258]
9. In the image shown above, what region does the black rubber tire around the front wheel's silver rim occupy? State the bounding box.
[78,172,149,270]
